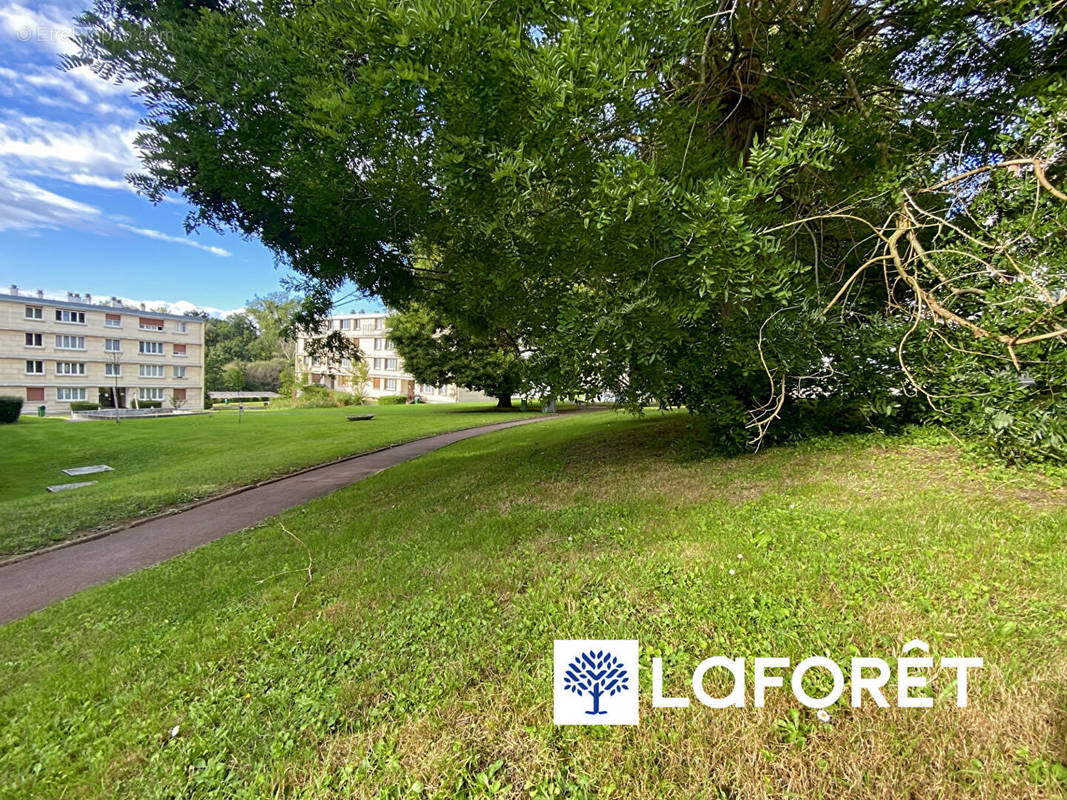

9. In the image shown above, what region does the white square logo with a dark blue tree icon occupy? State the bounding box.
[553,639,638,725]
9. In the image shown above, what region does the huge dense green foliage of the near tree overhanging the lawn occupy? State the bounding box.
[74,0,1067,459]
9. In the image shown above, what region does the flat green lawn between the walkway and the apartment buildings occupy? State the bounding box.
[0,404,533,556]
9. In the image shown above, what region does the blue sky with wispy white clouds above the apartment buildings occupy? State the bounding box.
[0,0,377,310]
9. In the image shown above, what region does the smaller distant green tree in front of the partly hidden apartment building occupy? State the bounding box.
[389,306,523,409]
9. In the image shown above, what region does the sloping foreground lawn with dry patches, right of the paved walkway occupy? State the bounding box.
[0,413,1067,800]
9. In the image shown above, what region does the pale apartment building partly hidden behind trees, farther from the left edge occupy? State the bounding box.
[296,314,493,403]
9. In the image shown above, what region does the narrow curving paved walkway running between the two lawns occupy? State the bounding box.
[0,416,552,624]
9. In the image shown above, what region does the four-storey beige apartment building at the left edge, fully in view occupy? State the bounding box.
[0,286,204,414]
